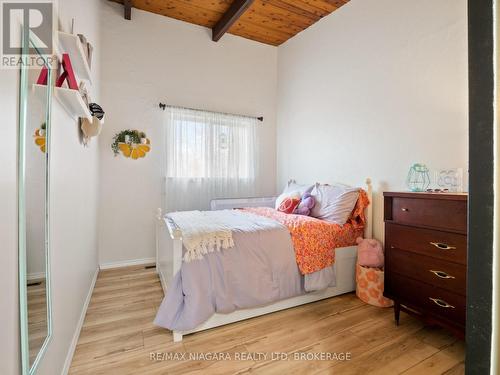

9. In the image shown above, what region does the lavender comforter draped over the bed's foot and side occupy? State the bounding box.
[155,212,335,331]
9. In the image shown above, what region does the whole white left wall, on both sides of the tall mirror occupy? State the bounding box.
[0,0,100,375]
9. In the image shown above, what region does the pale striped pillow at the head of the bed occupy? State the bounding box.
[311,184,359,225]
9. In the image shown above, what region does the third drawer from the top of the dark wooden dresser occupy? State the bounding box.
[386,249,467,296]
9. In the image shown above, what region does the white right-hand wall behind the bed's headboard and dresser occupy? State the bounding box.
[277,0,468,239]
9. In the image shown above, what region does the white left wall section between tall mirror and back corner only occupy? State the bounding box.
[38,0,101,375]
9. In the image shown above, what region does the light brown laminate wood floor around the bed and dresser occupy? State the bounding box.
[70,266,465,375]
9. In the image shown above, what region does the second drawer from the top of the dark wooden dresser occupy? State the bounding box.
[385,223,467,265]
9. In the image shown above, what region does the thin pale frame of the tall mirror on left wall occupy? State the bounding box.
[18,28,52,375]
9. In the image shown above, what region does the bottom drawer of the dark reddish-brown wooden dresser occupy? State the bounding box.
[390,274,465,326]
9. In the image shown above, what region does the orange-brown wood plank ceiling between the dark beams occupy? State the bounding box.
[111,0,349,46]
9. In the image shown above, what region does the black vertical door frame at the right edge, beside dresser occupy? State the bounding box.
[465,0,495,374]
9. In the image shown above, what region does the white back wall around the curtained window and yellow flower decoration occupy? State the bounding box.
[99,2,277,264]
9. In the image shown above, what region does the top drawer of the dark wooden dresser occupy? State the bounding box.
[388,197,467,233]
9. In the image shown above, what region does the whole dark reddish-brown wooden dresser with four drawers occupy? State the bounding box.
[384,192,467,337]
